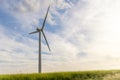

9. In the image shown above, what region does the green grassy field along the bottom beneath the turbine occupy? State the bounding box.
[0,70,120,80]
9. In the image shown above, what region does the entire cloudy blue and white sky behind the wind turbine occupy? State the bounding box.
[0,0,120,74]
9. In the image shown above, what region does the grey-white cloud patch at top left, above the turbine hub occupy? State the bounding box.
[0,0,70,29]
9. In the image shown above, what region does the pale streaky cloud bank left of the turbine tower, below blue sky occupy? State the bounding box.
[0,26,37,74]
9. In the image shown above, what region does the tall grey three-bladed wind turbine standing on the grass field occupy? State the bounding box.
[29,6,50,73]
